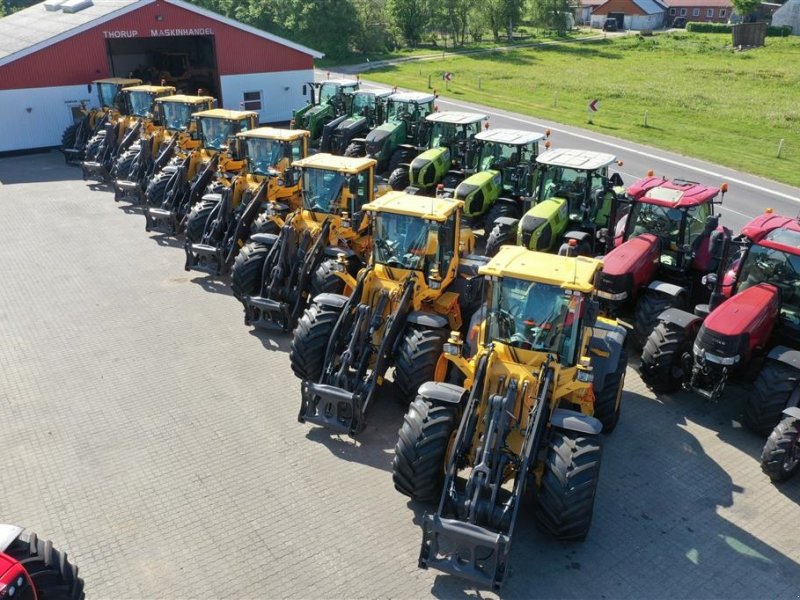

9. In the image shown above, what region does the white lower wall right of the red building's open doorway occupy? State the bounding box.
[220,69,314,123]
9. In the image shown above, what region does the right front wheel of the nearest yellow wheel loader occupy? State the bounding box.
[536,429,602,541]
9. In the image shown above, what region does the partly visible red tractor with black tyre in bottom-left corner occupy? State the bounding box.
[0,525,84,600]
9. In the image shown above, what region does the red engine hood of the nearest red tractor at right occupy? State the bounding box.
[703,283,780,342]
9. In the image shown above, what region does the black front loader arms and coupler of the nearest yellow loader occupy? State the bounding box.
[419,355,553,590]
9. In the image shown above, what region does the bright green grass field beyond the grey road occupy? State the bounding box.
[367,32,800,186]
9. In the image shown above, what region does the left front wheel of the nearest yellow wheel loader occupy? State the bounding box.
[392,396,460,502]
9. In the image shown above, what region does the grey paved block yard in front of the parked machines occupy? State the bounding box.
[0,152,800,599]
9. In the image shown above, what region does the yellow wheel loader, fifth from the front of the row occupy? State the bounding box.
[144,108,258,235]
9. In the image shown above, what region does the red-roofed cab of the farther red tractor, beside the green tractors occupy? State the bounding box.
[615,176,728,271]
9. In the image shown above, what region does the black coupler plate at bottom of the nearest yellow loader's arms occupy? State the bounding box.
[419,514,511,590]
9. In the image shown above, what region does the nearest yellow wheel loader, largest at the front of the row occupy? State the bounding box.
[392,246,626,590]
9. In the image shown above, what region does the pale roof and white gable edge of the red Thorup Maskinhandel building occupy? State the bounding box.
[0,0,324,65]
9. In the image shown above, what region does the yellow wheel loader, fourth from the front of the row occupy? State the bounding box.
[184,127,309,275]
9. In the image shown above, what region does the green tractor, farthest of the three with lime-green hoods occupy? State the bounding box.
[389,111,489,196]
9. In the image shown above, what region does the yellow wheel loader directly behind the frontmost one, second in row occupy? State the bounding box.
[289,191,482,436]
